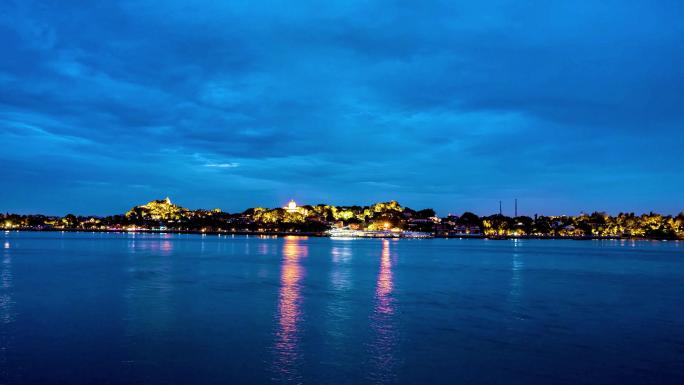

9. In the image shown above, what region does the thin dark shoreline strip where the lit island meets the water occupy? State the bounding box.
[3,228,681,241]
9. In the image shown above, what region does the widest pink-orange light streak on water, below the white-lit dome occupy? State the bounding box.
[273,236,308,384]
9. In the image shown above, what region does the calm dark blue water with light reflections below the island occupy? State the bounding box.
[0,232,684,385]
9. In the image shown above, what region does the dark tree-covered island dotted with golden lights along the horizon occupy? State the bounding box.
[0,198,684,240]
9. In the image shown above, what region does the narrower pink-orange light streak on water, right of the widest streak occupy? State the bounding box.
[369,239,398,384]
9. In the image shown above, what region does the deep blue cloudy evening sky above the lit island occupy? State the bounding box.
[0,0,684,215]
